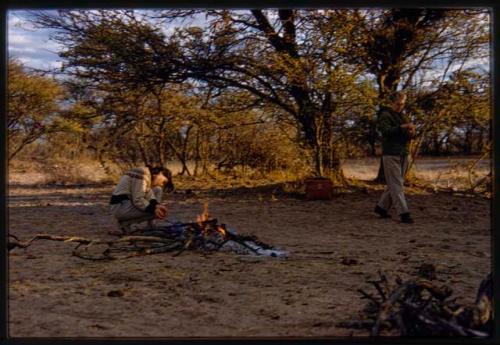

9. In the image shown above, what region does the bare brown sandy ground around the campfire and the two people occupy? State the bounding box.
[8,177,491,337]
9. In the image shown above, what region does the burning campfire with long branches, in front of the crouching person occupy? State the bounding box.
[9,203,287,260]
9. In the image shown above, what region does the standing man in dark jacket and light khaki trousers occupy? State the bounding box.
[375,91,415,224]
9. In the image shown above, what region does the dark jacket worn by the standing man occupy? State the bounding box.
[377,106,411,156]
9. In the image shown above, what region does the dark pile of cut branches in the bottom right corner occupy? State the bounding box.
[337,272,493,337]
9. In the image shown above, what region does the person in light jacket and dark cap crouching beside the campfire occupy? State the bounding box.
[110,167,174,233]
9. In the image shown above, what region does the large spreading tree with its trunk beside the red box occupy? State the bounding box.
[30,9,372,180]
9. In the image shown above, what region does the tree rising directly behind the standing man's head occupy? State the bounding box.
[348,9,489,181]
